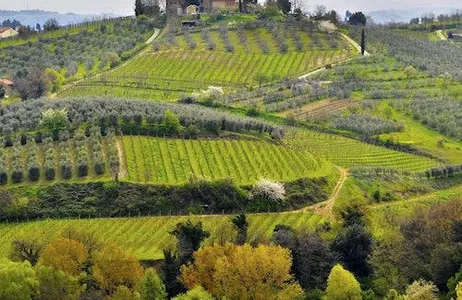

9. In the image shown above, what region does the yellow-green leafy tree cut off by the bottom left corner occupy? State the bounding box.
[0,259,39,300]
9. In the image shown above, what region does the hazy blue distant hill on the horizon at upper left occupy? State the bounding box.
[0,10,121,26]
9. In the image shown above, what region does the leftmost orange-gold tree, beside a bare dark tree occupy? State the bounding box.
[39,238,89,276]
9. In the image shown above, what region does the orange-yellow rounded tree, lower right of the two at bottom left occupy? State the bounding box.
[92,245,143,295]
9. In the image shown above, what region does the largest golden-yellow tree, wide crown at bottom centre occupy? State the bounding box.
[181,244,303,300]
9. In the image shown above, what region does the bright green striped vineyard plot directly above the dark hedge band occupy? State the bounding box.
[122,136,332,184]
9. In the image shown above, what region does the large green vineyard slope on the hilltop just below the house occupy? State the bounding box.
[60,29,354,100]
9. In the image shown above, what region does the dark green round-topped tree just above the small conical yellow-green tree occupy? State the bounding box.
[332,225,373,277]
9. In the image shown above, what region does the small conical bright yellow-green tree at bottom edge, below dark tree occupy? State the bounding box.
[324,264,361,300]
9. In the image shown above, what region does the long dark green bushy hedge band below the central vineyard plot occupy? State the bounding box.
[0,178,327,220]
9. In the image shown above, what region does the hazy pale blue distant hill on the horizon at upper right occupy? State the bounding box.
[366,7,457,24]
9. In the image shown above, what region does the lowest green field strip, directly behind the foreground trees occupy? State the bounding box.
[0,212,324,259]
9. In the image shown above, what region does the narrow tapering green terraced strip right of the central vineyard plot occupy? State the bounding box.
[284,130,440,172]
